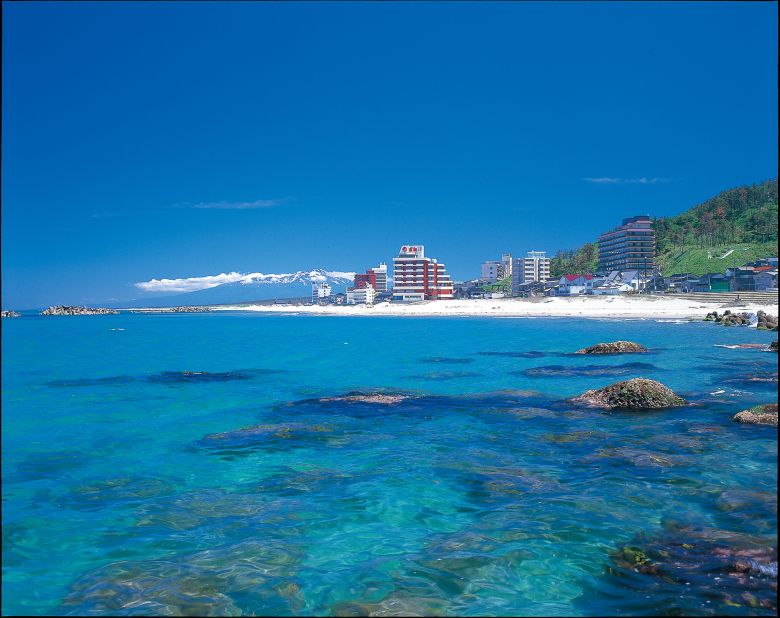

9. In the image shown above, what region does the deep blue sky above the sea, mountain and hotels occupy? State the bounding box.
[2,2,778,308]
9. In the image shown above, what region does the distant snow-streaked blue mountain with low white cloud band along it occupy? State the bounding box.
[118,268,355,307]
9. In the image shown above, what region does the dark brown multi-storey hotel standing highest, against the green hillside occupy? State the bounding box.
[599,215,655,273]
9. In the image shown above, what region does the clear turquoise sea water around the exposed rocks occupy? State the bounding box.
[2,313,777,616]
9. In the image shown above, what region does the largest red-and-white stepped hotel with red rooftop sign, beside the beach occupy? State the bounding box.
[393,245,453,301]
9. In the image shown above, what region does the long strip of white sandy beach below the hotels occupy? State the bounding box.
[207,296,778,320]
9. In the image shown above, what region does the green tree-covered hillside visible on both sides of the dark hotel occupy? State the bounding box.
[550,178,777,277]
